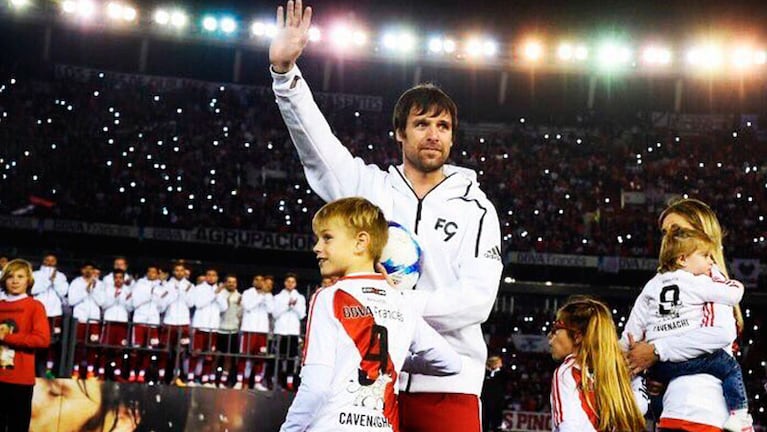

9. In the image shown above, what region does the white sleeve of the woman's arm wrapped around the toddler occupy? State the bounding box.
[653,304,737,362]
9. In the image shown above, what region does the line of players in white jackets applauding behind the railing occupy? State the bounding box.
[32,254,314,390]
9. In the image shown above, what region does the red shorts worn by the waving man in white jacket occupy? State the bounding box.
[398,392,482,432]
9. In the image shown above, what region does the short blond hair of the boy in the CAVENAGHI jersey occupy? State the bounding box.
[312,197,389,263]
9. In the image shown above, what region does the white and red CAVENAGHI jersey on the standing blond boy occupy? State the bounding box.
[281,273,461,432]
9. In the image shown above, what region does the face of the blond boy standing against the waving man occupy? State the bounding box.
[312,218,357,277]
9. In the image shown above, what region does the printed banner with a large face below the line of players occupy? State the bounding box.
[29,378,293,432]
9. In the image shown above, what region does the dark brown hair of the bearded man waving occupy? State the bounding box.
[392,83,458,140]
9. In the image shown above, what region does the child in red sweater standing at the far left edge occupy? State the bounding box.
[0,259,51,432]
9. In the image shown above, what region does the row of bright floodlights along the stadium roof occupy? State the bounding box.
[9,0,767,70]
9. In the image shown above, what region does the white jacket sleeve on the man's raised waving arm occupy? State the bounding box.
[272,66,385,201]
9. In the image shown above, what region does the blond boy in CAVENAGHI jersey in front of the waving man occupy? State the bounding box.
[280,198,461,432]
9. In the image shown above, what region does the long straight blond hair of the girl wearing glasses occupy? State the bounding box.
[557,297,645,432]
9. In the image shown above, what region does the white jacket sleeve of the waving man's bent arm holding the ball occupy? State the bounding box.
[410,200,503,333]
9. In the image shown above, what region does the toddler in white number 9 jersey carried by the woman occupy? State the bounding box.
[622,226,753,432]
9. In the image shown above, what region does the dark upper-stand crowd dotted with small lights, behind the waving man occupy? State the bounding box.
[0,66,767,257]
